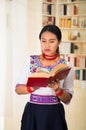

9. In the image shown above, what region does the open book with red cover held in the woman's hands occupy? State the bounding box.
[27,63,71,87]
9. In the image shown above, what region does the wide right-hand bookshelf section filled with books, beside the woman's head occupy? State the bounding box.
[56,0,86,88]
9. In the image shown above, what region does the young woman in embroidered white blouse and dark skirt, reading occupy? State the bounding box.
[15,25,74,130]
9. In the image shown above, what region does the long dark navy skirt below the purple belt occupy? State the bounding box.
[21,102,68,130]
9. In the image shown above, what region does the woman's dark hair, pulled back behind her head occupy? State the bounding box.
[39,25,62,54]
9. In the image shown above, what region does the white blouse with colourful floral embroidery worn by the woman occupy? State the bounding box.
[16,55,74,98]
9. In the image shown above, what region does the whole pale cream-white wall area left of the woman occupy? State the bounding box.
[0,0,42,130]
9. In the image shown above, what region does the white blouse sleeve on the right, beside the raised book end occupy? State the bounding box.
[61,64,74,95]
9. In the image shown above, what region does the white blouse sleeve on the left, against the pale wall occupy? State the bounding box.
[16,57,30,87]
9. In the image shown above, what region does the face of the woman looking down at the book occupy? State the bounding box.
[40,31,60,55]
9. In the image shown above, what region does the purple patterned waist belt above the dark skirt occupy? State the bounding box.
[30,94,60,104]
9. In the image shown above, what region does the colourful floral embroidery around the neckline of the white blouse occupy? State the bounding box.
[30,55,67,73]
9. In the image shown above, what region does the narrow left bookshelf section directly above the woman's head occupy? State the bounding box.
[42,0,56,26]
